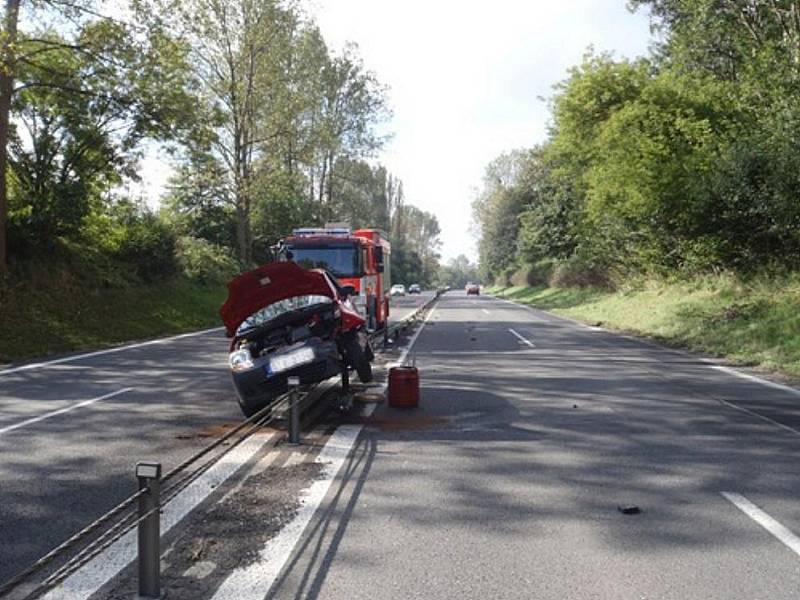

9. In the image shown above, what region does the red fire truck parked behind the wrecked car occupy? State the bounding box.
[279,224,392,330]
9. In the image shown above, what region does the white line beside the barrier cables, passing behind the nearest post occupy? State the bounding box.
[43,434,277,600]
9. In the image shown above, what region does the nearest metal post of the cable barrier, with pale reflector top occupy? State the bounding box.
[136,462,163,600]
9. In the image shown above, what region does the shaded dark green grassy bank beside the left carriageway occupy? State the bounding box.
[0,268,226,364]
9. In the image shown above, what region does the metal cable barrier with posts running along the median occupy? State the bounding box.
[0,291,443,600]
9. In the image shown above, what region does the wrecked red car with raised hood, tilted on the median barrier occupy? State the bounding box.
[220,262,374,416]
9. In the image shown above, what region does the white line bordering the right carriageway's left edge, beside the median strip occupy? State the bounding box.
[212,298,436,600]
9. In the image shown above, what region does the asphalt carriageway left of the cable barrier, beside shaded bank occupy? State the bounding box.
[0,293,432,582]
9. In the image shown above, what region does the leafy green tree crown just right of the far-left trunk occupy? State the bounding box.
[8,20,189,250]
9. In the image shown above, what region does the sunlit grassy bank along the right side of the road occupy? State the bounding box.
[487,276,800,378]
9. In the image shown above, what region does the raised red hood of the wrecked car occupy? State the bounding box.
[219,262,336,337]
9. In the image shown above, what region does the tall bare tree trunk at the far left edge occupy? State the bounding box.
[0,0,22,273]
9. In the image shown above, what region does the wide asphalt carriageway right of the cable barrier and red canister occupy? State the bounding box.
[268,292,800,600]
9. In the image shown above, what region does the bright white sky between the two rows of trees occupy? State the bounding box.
[310,0,650,260]
